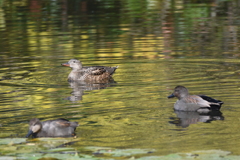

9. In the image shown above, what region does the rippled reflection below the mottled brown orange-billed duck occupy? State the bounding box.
[65,79,116,102]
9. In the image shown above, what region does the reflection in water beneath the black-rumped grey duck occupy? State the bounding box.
[170,111,224,128]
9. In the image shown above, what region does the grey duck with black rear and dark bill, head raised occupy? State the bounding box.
[168,86,223,112]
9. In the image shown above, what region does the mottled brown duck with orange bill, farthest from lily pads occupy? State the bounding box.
[62,59,118,82]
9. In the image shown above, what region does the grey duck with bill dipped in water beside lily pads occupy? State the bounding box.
[26,118,78,138]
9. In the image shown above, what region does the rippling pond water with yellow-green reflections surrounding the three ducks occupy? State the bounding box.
[0,0,240,159]
